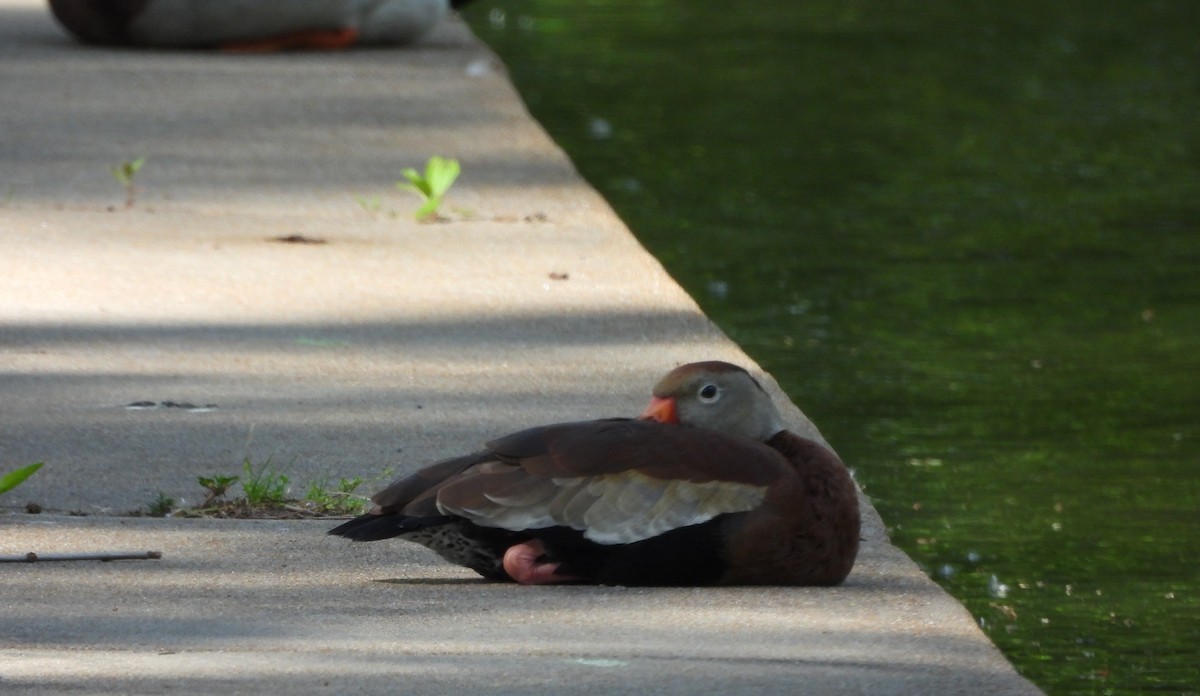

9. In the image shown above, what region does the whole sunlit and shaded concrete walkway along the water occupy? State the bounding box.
[0,0,1038,695]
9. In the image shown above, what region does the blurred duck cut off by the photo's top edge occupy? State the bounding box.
[50,0,468,52]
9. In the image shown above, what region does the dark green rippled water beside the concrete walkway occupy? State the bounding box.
[453,0,1200,695]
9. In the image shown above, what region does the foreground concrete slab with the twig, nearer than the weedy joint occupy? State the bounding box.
[0,516,1036,695]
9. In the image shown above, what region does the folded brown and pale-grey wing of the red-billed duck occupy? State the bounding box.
[417,420,786,544]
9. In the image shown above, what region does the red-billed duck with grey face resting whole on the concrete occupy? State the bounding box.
[329,361,859,586]
